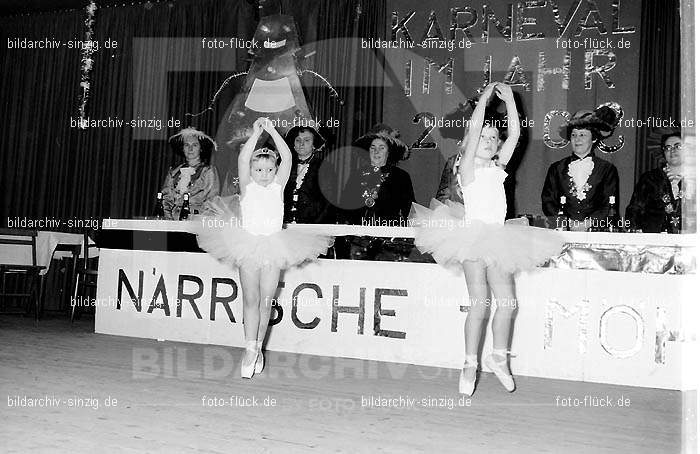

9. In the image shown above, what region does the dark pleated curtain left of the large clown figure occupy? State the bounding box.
[0,0,255,226]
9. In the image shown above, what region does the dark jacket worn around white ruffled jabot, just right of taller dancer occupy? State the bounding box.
[542,151,620,221]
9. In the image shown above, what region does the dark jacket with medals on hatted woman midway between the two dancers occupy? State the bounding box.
[342,165,416,227]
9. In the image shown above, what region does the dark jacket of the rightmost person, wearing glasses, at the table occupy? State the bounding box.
[625,169,682,233]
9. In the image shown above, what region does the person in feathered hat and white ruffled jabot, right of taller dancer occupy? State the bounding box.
[542,106,620,230]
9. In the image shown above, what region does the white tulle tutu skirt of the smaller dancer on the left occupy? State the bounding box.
[193,195,333,269]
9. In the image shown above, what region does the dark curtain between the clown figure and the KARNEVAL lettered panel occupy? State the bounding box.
[271,0,387,203]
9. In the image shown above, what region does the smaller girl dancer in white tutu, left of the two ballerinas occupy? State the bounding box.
[197,118,332,378]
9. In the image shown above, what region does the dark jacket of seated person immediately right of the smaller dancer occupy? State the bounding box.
[284,152,335,224]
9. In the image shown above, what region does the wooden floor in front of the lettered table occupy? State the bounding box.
[0,316,682,453]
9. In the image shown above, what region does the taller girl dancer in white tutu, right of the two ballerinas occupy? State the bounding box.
[412,83,563,396]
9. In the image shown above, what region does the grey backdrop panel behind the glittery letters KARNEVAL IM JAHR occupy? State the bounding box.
[384,0,644,214]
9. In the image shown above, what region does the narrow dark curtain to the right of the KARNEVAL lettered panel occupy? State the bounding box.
[635,0,681,181]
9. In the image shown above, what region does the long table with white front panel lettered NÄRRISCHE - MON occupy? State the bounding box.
[95,219,698,390]
